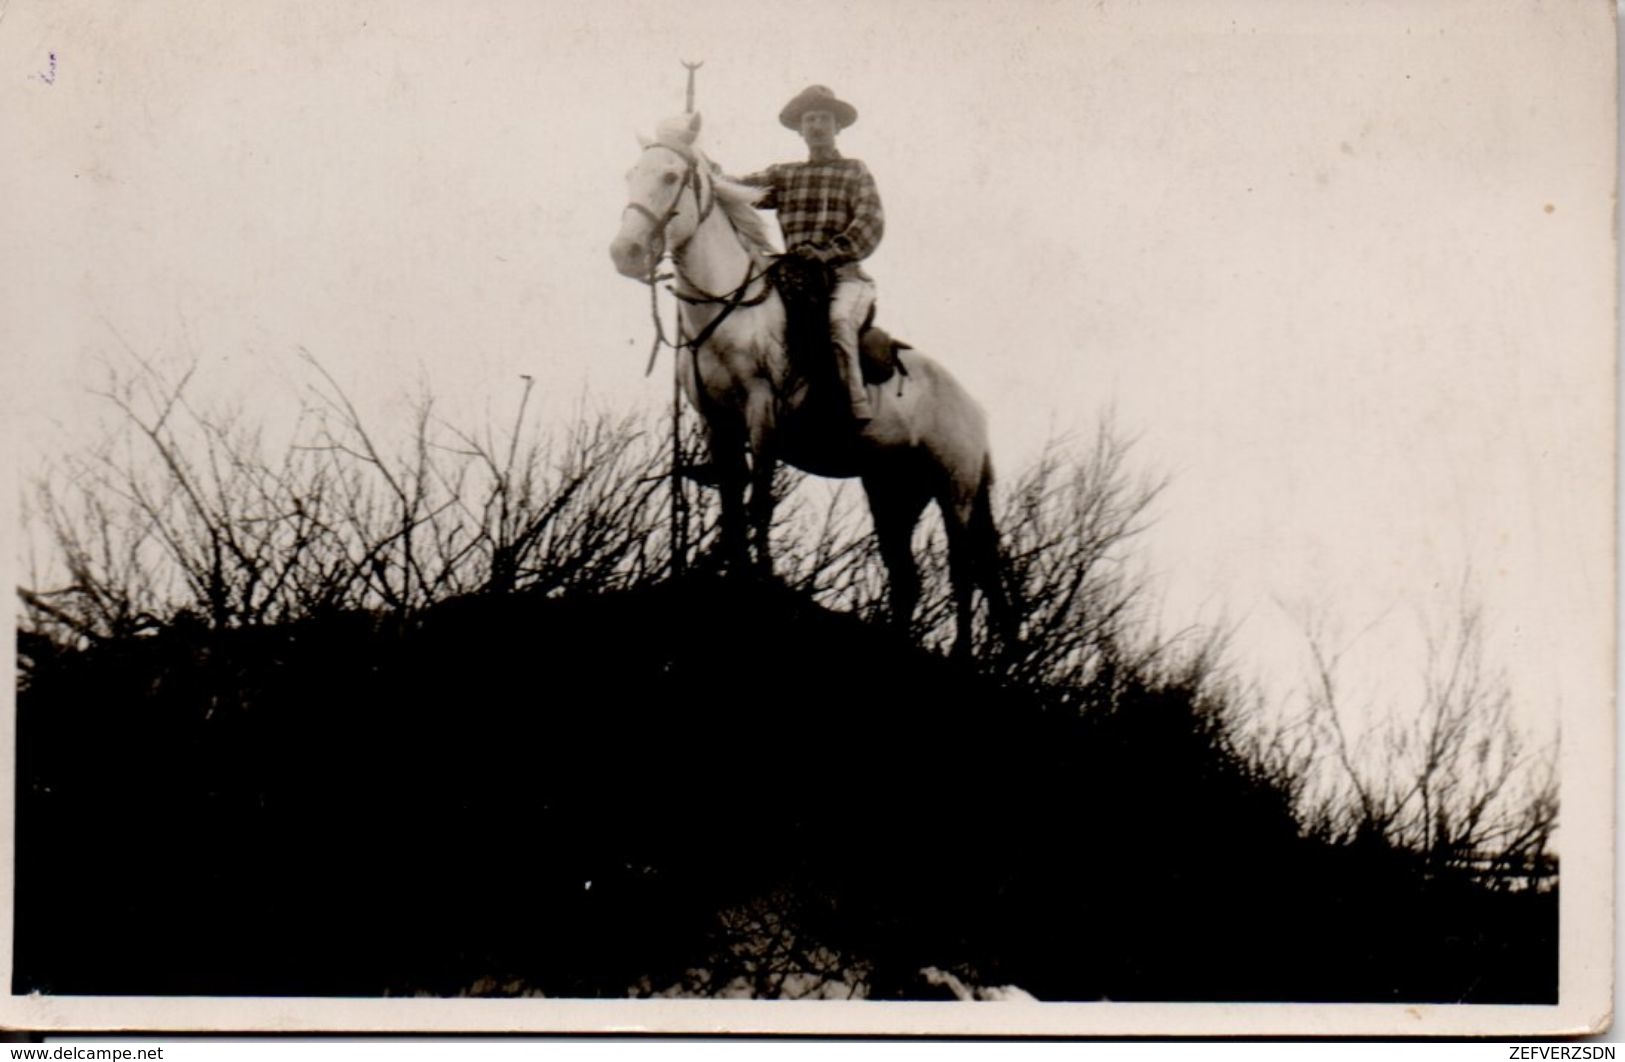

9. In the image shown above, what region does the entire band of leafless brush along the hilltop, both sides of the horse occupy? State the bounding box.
[20,356,1558,885]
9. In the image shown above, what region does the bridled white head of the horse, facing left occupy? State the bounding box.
[609,114,715,281]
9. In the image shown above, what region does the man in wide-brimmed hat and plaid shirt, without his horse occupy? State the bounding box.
[741,84,886,427]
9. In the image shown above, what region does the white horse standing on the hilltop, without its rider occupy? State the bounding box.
[609,114,1012,656]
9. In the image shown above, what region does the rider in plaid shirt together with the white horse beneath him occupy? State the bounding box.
[609,97,1019,654]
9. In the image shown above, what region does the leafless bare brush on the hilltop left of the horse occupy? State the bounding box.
[20,356,692,643]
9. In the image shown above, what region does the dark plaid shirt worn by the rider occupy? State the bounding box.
[741,151,886,265]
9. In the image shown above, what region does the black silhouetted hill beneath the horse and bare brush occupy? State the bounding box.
[13,576,1557,1002]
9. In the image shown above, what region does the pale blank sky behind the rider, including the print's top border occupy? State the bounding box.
[0,0,1614,750]
